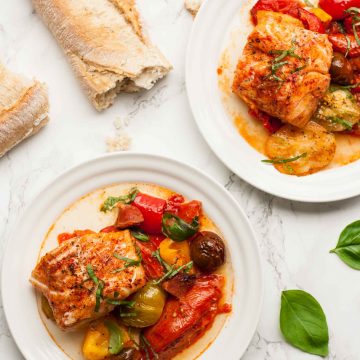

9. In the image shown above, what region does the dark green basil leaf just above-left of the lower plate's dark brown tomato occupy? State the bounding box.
[162,213,200,241]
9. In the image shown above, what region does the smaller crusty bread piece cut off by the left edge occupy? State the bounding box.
[0,64,49,157]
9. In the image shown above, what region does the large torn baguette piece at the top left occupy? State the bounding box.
[33,0,171,110]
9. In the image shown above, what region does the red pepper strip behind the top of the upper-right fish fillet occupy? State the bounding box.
[250,0,325,34]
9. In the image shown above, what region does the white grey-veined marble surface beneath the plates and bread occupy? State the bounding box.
[0,0,360,360]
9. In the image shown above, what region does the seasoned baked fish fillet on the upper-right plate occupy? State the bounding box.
[233,11,332,127]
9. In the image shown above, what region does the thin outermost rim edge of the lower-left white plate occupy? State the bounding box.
[1,151,265,360]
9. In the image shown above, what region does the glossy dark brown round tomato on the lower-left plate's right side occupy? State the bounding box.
[190,231,225,272]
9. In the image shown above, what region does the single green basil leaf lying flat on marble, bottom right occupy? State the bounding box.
[280,290,329,356]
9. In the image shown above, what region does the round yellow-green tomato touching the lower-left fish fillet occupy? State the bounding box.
[120,282,166,328]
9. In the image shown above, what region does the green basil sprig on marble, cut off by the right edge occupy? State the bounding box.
[330,220,360,270]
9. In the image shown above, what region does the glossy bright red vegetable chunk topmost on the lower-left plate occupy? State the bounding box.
[132,193,166,234]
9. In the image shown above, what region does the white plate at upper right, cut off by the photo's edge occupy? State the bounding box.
[186,0,360,202]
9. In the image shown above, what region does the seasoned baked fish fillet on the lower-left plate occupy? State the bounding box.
[30,230,146,330]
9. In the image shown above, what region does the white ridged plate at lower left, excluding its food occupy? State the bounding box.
[2,153,263,360]
